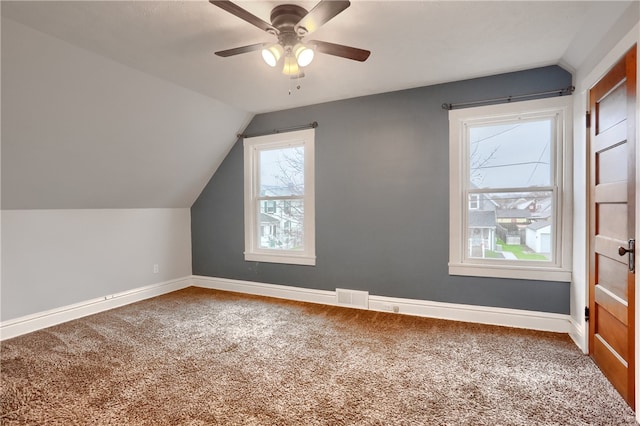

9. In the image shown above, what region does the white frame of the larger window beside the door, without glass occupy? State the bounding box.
[449,96,573,282]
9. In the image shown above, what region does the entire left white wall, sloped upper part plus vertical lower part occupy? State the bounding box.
[0,17,245,321]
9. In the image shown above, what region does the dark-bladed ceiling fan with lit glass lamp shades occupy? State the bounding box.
[209,0,371,78]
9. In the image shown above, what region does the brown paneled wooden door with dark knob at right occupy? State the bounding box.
[588,46,637,408]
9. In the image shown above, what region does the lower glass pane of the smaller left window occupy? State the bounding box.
[258,199,304,250]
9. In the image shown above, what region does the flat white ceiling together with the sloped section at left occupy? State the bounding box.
[0,0,637,209]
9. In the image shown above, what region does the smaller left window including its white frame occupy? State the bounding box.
[244,129,316,265]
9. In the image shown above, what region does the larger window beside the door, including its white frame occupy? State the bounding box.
[449,96,571,281]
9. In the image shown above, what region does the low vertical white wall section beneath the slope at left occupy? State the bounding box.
[0,208,191,321]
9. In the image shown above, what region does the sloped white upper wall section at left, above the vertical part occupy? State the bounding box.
[1,17,252,209]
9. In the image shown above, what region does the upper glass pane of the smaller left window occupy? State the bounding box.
[259,146,304,197]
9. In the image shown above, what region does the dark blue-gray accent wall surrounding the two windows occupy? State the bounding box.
[191,66,571,314]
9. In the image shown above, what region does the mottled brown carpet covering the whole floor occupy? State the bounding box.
[0,288,636,425]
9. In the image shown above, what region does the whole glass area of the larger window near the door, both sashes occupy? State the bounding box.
[466,117,556,262]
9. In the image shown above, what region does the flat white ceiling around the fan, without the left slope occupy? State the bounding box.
[1,0,630,113]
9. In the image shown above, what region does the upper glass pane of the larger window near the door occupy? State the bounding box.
[468,118,553,188]
